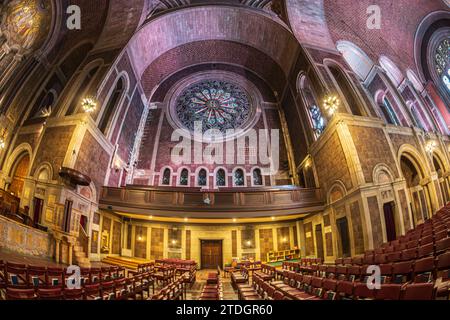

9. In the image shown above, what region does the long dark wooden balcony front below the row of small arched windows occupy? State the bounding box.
[99,185,324,218]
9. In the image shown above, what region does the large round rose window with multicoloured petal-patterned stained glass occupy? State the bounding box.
[175,80,251,133]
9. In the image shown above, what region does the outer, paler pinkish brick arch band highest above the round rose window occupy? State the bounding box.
[127,5,300,78]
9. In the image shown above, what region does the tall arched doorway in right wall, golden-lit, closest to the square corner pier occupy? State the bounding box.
[400,154,431,224]
